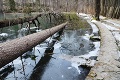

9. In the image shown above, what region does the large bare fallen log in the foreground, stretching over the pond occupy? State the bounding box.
[0,22,67,68]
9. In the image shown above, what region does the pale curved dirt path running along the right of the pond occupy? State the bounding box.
[86,22,120,80]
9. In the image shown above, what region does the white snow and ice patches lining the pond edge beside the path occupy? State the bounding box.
[60,13,100,74]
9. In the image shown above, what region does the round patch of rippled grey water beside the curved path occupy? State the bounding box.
[61,29,94,56]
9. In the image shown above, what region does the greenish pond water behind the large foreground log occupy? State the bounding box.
[0,14,63,42]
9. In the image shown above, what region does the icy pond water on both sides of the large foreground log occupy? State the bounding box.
[0,12,100,80]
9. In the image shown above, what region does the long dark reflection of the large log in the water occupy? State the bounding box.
[29,30,63,80]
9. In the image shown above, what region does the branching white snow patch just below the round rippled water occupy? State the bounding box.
[60,42,100,74]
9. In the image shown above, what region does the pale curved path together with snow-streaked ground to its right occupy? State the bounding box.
[79,14,120,80]
